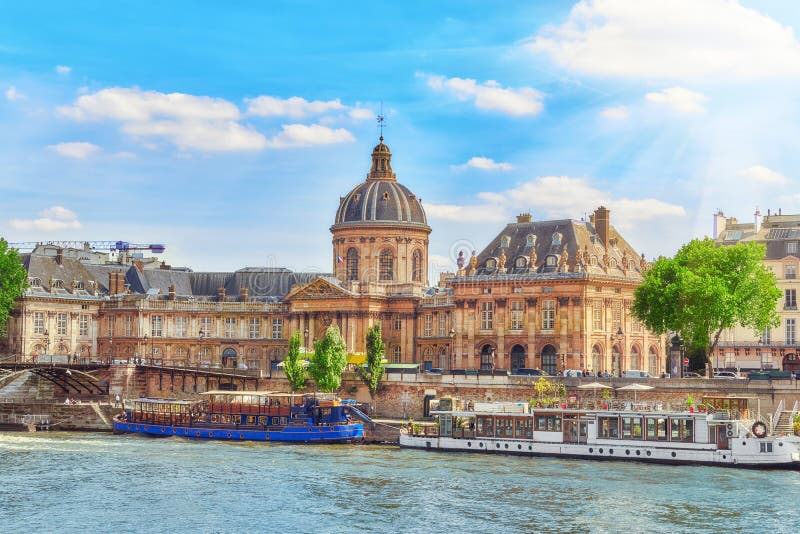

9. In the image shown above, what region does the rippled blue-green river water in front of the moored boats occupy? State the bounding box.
[0,432,800,533]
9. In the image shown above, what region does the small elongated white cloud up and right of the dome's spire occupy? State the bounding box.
[422,75,543,117]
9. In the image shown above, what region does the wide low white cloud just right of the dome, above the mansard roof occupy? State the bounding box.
[425,176,686,229]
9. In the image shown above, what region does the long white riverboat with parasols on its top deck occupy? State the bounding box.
[400,397,800,469]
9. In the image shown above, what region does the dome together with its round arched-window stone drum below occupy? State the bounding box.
[331,136,431,289]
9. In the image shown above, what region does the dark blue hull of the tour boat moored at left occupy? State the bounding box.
[114,420,364,443]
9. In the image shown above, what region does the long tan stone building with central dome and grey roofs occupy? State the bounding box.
[10,137,664,375]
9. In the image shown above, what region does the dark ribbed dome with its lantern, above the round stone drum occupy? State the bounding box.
[334,136,428,228]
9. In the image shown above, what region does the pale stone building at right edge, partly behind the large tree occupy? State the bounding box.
[711,210,800,371]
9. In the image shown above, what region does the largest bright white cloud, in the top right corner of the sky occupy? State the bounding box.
[525,0,800,79]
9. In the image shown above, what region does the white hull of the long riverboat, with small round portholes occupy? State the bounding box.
[400,434,800,469]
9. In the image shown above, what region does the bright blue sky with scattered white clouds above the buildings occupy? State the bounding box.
[0,0,800,280]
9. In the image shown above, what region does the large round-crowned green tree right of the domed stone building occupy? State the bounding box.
[631,239,781,357]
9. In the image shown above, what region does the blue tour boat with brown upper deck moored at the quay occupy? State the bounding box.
[114,391,371,443]
